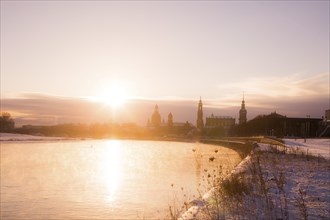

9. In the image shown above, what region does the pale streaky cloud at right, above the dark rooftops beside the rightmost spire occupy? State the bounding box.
[213,73,330,117]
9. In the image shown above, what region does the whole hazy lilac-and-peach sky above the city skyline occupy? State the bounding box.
[1,0,330,124]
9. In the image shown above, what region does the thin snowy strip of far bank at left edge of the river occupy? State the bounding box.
[0,133,72,141]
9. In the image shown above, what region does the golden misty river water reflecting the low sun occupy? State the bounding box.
[0,140,240,219]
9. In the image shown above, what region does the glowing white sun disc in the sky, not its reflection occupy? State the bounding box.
[93,84,128,108]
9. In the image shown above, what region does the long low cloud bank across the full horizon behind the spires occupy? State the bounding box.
[1,80,330,126]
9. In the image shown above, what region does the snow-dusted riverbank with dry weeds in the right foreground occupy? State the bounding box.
[179,139,330,220]
